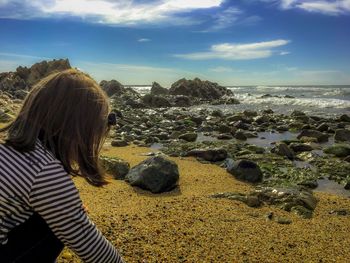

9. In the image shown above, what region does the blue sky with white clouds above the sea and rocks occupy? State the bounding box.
[0,0,350,86]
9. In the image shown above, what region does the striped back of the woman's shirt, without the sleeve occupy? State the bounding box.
[0,142,55,244]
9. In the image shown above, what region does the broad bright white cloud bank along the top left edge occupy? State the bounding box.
[0,0,224,25]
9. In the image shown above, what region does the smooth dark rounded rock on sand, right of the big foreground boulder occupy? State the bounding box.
[227,159,263,183]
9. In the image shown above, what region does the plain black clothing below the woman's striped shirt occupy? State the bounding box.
[0,213,64,263]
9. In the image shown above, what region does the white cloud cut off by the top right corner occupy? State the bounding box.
[266,0,350,15]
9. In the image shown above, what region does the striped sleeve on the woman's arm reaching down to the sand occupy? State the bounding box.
[29,161,123,263]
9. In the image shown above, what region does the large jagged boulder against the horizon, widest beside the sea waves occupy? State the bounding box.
[169,78,233,100]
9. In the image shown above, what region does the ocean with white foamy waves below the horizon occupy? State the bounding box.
[131,85,350,117]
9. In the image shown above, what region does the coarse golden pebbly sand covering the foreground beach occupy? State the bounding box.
[58,146,350,263]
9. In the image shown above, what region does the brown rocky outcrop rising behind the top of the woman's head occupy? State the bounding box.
[0,59,71,99]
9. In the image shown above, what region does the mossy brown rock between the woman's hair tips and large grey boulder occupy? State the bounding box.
[100,156,130,180]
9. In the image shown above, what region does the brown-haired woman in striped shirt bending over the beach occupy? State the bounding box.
[0,69,123,263]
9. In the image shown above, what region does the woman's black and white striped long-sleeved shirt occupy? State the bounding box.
[0,140,123,263]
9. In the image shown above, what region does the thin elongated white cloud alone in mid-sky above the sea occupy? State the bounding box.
[174,39,290,60]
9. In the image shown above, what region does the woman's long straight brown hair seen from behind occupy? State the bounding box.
[0,69,109,186]
